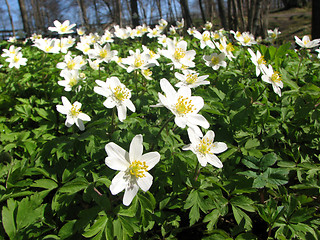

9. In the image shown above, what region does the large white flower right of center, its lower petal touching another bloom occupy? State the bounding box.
[156,78,210,136]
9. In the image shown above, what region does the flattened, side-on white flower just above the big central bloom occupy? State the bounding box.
[174,70,210,88]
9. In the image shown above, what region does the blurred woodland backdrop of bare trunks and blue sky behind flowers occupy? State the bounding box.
[0,0,320,39]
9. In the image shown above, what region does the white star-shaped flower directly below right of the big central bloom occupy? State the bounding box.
[182,129,228,168]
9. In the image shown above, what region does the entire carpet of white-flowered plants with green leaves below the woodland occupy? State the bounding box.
[0,20,320,240]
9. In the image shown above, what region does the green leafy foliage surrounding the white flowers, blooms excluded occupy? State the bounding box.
[0,27,320,240]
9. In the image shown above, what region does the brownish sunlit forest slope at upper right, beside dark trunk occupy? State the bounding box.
[269,8,312,42]
